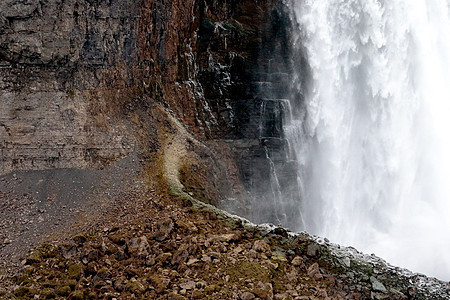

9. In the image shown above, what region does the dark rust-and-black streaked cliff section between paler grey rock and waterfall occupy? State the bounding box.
[140,0,281,138]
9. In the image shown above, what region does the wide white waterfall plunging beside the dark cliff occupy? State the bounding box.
[288,0,450,280]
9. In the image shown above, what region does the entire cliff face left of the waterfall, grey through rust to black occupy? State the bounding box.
[0,0,286,204]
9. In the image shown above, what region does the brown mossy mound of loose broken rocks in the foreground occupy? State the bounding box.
[1,185,450,299]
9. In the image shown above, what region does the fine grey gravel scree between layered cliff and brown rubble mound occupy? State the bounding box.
[0,155,140,273]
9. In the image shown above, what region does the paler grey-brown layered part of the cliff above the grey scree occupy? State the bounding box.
[0,0,139,174]
